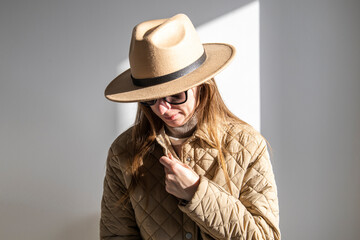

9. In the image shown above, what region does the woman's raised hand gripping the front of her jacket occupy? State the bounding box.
[160,154,200,201]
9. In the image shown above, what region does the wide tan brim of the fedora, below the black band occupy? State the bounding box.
[105,43,236,102]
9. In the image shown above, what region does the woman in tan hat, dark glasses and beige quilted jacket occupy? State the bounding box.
[100,14,280,240]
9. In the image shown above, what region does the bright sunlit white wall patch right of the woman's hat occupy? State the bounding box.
[197,1,260,130]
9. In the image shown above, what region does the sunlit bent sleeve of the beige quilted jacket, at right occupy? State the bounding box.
[179,140,280,240]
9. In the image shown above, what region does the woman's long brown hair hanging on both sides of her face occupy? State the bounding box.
[120,78,249,202]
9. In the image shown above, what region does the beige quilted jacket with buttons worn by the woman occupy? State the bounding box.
[100,123,280,240]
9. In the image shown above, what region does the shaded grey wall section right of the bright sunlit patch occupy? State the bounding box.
[260,0,360,240]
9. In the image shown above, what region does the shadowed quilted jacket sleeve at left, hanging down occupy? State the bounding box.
[100,149,141,240]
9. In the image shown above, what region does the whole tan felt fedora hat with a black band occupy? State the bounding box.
[105,14,235,102]
